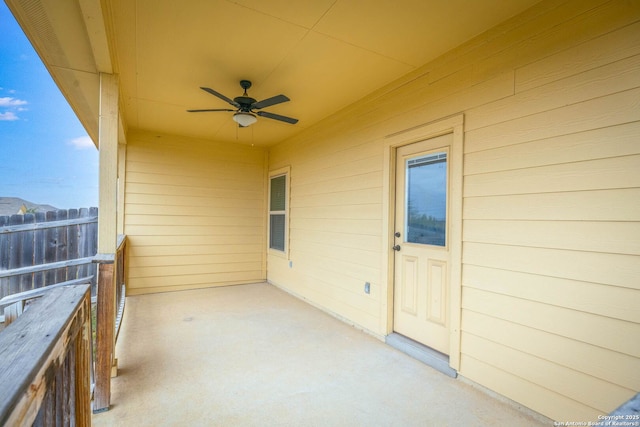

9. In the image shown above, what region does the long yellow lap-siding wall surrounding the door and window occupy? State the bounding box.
[268,0,640,421]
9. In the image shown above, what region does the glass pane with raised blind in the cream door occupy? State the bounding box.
[405,152,447,246]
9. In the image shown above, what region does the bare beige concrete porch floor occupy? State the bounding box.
[93,284,550,426]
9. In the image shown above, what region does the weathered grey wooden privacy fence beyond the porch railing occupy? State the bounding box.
[0,208,98,299]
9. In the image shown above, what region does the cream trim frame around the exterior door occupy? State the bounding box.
[380,114,464,371]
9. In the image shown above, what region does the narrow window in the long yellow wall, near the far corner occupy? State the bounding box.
[269,170,289,252]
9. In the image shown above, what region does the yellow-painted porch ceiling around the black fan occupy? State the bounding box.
[7,0,539,146]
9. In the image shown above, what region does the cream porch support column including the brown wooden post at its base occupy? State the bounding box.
[93,74,118,413]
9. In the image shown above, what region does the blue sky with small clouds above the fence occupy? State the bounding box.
[0,1,98,209]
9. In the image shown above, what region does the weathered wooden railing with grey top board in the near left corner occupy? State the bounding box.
[0,285,91,426]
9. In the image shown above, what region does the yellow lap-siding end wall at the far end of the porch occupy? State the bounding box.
[125,132,266,295]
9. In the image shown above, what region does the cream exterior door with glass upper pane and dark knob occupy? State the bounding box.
[393,134,453,354]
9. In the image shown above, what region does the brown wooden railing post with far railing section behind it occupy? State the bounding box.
[93,236,127,413]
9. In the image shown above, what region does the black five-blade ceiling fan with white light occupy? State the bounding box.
[187,80,298,127]
